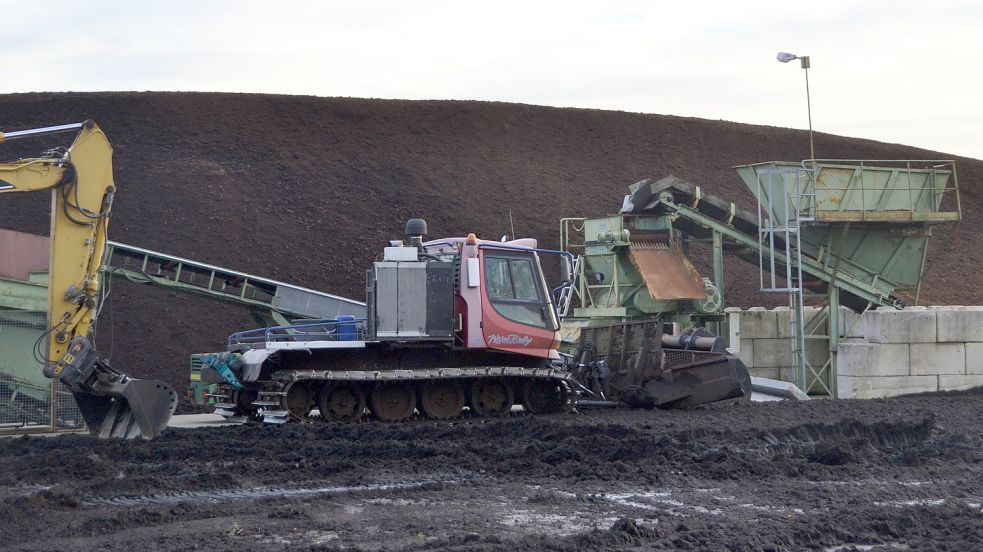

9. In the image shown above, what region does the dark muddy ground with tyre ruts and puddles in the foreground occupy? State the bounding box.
[0,391,983,551]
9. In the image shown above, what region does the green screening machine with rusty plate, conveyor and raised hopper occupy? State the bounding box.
[560,160,961,396]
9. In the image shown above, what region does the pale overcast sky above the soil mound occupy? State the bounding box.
[0,0,983,159]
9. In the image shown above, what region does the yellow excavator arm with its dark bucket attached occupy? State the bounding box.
[0,121,177,438]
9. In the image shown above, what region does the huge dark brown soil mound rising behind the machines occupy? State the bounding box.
[0,93,983,398]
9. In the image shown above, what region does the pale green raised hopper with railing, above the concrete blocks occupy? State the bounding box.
[736,160,961,310]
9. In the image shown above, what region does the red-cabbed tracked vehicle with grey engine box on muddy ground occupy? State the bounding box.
[202,219,575,423]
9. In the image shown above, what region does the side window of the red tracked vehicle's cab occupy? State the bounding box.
[485,255,555,330]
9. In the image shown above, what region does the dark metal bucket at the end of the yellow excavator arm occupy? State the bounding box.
[45,337,177,439]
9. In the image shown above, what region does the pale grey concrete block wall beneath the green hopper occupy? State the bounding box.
[727,307,983,398]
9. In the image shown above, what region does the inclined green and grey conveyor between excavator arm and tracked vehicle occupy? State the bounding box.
[103,241,365,324]
